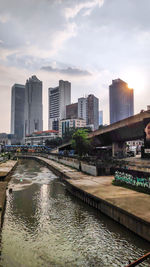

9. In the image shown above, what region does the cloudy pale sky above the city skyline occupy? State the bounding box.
[0,0,150,133]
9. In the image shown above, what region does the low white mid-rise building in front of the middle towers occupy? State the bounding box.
[59,119,86,137]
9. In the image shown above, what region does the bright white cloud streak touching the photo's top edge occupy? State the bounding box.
[64,0,104,19]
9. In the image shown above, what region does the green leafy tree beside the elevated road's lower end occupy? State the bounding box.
[72,129,90,156]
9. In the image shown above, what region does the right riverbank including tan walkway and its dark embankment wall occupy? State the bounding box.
[28,157,150,244]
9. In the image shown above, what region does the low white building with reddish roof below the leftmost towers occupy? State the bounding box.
[25,130,58,145]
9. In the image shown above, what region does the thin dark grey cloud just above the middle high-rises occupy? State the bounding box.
[41,66,91,76]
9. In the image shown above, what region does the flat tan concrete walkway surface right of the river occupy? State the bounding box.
[38,157,150,223]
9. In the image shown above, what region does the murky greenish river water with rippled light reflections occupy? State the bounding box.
[0,160,150,267]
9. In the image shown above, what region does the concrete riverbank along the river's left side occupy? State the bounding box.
[0,160,17,227]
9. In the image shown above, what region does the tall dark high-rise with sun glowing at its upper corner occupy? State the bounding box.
[109,79,134,123]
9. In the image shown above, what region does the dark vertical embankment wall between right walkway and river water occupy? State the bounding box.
[24,157,150,244]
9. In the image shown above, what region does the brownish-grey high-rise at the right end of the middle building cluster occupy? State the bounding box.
[87,95,99,130]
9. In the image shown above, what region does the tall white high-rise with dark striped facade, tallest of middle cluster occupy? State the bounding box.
[48,80,71,131]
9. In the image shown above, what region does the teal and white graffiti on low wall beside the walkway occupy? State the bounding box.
[115,171,150,189]
